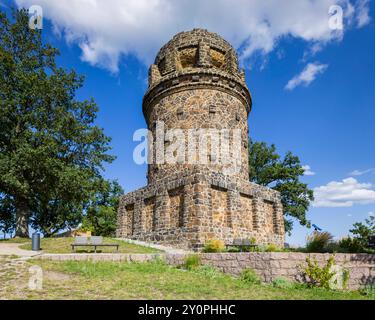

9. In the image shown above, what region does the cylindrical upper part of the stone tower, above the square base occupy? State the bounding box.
[143,29,251,183]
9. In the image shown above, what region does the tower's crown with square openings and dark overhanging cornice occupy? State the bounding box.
[143,29,251,115]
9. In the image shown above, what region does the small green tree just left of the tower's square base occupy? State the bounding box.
[82,181,124,237]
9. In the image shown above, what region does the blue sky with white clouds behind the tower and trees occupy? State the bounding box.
[0,0,375,244]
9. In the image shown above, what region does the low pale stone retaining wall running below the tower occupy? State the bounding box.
[38,252,375,289]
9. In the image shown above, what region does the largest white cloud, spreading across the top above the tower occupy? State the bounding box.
[15,0,369,72]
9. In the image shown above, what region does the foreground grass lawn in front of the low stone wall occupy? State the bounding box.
[0,260,374,300]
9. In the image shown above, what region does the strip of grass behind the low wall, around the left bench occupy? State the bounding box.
[0,238,160,253]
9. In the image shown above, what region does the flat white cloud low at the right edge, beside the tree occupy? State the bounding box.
[313,177,375,207]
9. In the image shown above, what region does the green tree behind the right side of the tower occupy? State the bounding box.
[249,140,314,234]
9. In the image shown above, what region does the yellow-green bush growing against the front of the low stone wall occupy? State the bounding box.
[303,256,336,289]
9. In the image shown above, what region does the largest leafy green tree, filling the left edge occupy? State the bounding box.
[0,10,114,237]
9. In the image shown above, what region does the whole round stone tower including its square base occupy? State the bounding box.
[117,29,284,249]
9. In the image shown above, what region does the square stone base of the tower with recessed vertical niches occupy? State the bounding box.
[117,170,284,250]
